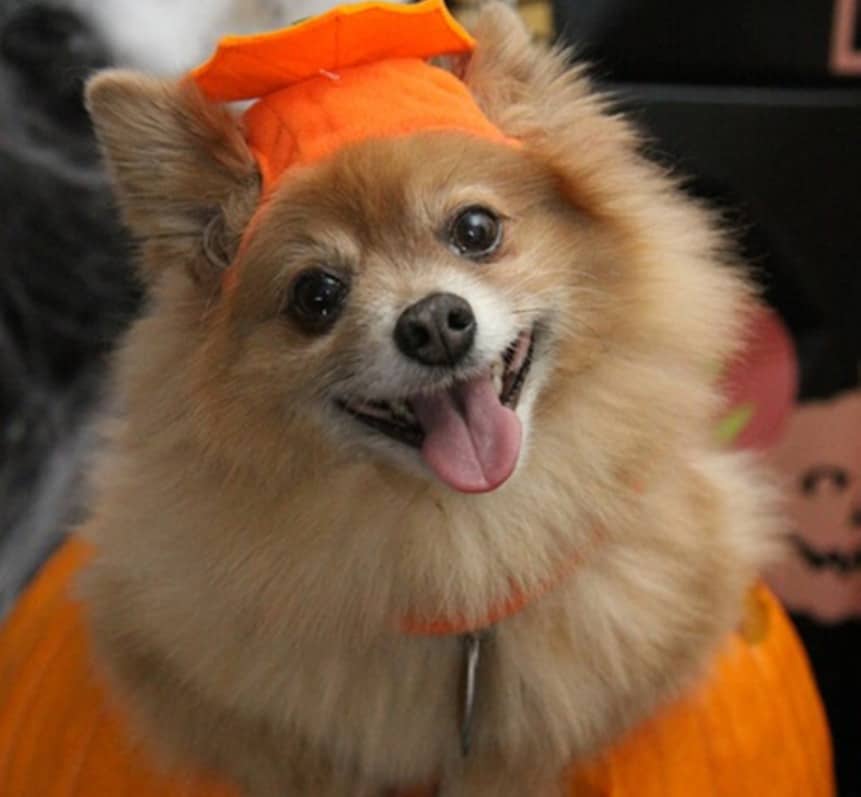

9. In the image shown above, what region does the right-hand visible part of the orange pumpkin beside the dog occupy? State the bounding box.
[569,587,835,797]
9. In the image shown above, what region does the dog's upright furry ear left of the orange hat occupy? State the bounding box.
[86,70,260,286]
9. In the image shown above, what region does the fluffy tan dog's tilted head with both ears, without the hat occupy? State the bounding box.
[84,7,738,492]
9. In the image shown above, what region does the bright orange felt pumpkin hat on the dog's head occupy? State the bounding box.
[191,0,513,193]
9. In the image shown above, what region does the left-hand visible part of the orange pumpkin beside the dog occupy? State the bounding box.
[0,539,239,797]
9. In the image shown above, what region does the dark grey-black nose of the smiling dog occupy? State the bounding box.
[395,293,476,365]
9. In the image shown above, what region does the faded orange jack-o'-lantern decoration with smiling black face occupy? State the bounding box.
[770,390,861,622]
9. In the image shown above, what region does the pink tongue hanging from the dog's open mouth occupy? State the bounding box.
[412,375,521,493]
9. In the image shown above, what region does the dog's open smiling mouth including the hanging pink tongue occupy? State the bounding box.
[338,331,535,493]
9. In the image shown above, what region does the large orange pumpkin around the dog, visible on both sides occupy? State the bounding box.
[0,540,834,797]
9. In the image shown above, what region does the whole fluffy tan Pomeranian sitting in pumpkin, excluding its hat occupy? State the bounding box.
[82,5,774,797]
